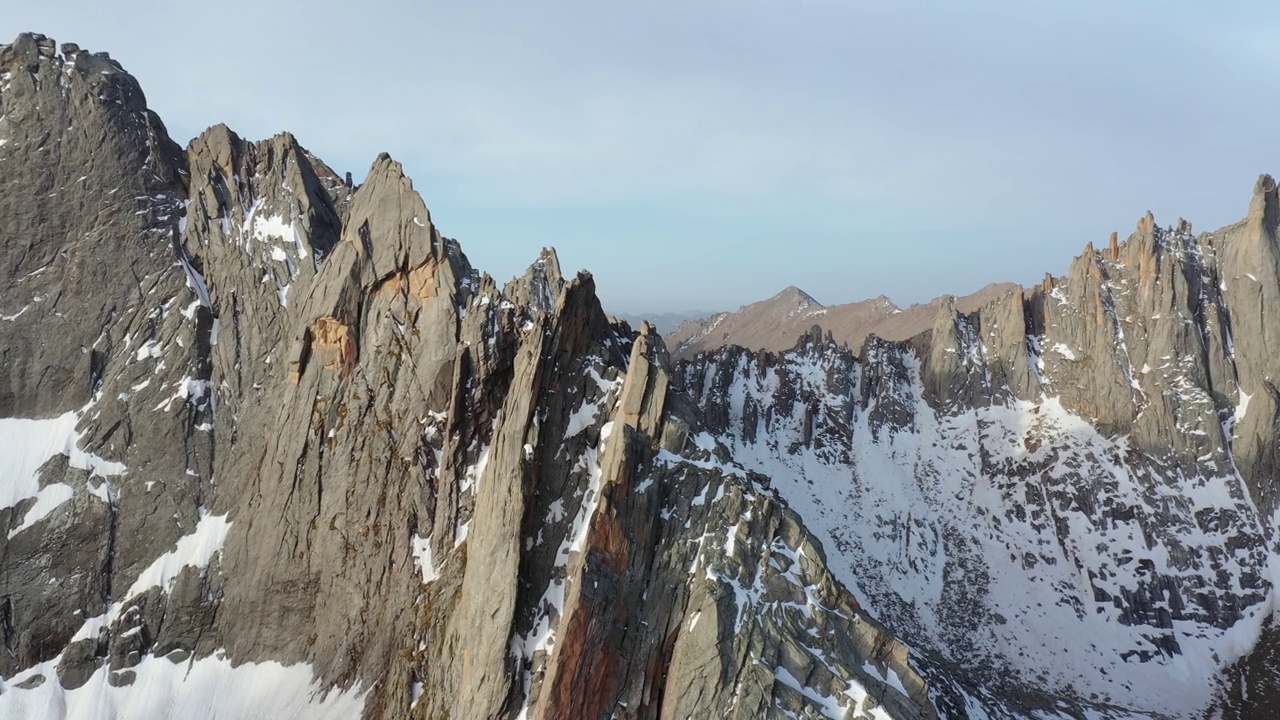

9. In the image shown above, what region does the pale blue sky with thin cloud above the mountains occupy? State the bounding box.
[0,0,1280,313]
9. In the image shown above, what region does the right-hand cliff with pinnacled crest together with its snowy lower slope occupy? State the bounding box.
[676,184,1280,716]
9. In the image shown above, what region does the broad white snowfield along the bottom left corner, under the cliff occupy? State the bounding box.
[0,652,365,720]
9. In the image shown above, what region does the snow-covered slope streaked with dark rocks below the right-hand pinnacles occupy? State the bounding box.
[686,345,1276,715]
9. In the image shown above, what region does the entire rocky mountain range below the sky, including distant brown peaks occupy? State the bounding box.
[0,33,1280,720]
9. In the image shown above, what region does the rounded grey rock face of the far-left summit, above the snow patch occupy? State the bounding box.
[0,36,183,416]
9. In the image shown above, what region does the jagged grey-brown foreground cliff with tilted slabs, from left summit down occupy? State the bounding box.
[0,35,936,719]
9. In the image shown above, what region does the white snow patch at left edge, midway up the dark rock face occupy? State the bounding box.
[0,413,128,509]
